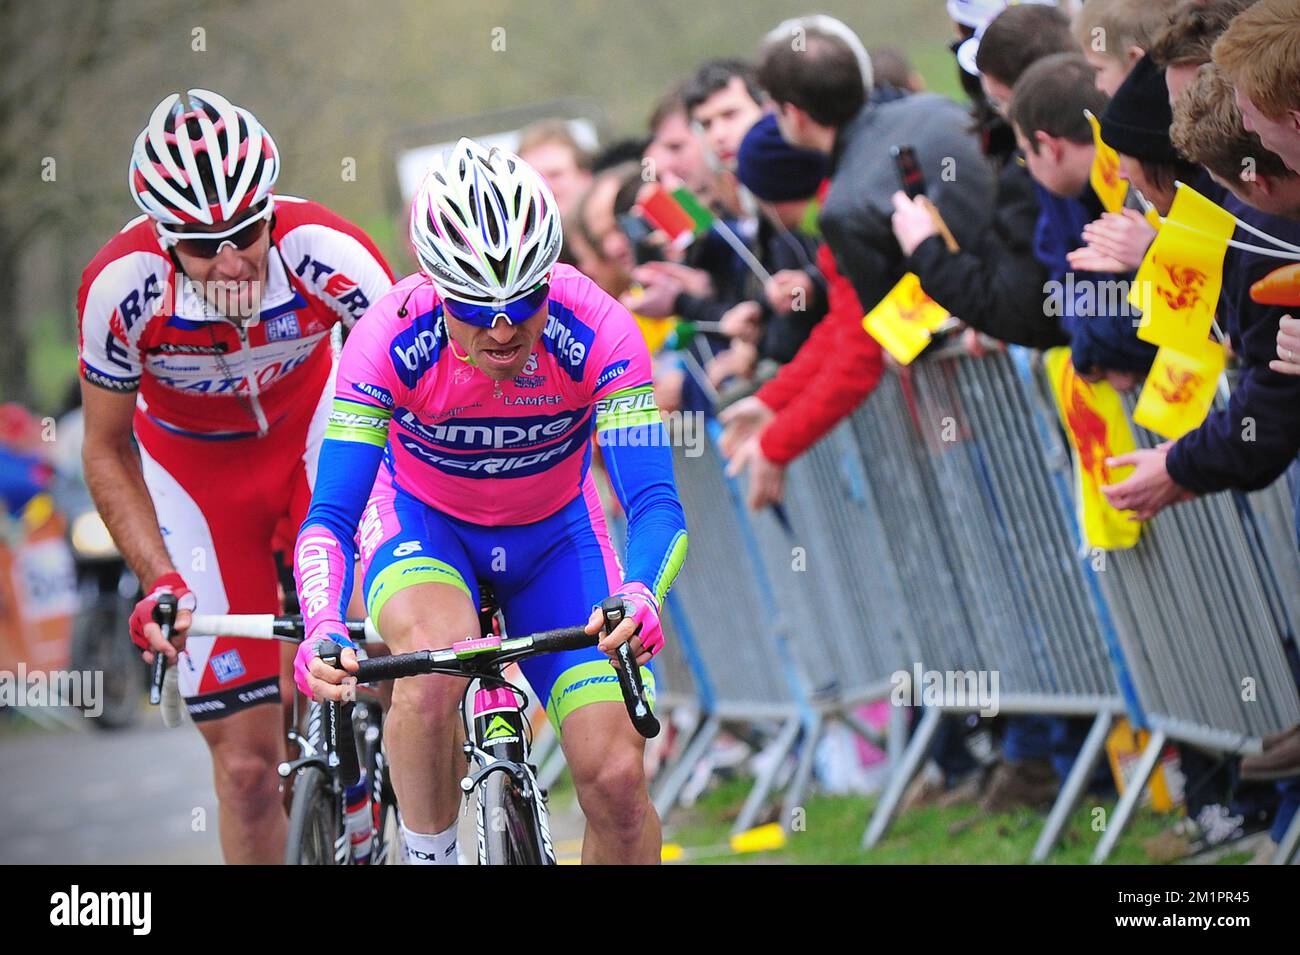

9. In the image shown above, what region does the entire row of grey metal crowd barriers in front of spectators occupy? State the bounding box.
[639,350,1300,860]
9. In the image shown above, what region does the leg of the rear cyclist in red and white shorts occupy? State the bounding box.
[138,427,287,863]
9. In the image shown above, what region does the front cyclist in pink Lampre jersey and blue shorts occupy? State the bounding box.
[295,139,686,861]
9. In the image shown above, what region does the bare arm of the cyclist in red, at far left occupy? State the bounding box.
[81,381,176,587]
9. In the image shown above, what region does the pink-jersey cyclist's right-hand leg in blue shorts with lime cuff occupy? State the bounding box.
[486,478,662,863]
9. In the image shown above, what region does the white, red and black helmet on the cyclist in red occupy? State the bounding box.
[129,90,280,226]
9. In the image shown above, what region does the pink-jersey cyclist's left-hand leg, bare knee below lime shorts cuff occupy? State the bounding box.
[359,472,478,846]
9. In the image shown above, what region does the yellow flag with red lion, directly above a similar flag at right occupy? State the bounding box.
[1128,186,1236,355]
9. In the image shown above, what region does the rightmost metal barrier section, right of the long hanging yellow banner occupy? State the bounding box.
[1093,399,1300,861]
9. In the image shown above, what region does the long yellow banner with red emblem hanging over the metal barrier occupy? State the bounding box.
[1043,348,1141,551]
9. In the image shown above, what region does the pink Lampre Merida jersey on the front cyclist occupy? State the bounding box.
[326,265,658,525]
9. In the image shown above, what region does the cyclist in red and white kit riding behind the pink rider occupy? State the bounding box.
[77,90,393,863]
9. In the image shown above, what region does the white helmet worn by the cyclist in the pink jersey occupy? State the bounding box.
[411,139,560,304]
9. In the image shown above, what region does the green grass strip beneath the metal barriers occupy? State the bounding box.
[664,780,1190,865]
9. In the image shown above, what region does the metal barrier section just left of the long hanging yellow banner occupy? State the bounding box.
[852,353,1123,859]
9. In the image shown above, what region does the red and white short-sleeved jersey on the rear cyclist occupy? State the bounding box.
[77,196,393,437]
